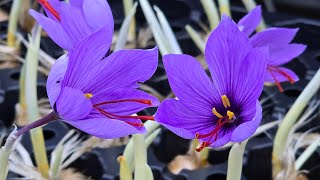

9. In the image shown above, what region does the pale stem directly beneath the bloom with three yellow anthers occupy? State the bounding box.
[227,140,248,180]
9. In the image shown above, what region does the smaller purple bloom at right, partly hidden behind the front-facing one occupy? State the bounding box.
[238,6,306,92]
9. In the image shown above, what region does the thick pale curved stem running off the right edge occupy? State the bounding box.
[272,69,320,177]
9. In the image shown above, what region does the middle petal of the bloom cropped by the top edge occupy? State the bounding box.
[59,3,94,43]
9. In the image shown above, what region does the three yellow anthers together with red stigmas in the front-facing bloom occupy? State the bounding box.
[196,95,236,152]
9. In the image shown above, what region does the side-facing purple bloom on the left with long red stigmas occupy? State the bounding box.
[47,27,159,138]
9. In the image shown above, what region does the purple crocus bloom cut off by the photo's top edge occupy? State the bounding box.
[30,0,114,51]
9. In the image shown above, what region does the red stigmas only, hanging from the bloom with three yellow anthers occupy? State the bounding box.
[196,116,232,152]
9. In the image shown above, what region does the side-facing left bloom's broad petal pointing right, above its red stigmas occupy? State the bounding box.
[79,48,158,94]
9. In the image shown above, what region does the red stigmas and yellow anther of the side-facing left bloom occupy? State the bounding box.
[84,93,154,127]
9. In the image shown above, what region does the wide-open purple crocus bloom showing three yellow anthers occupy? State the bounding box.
[155,16,268,151]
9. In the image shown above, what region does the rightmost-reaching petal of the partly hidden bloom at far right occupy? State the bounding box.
[268,44,307,66]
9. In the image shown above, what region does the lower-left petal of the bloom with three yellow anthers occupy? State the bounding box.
[155,99,215,139]
